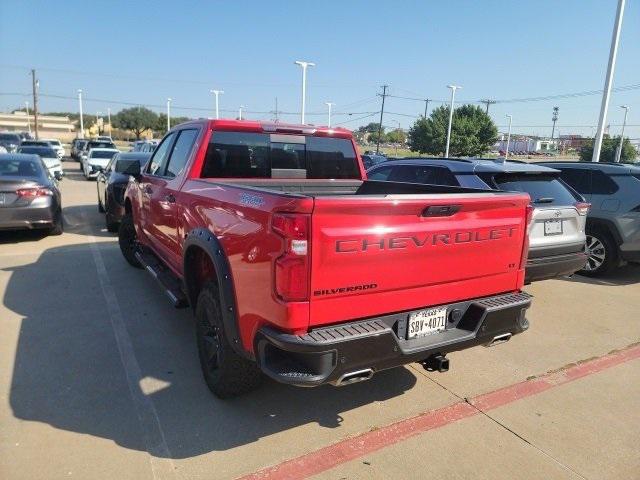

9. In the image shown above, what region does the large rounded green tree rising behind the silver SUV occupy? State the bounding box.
[409,105,498,157]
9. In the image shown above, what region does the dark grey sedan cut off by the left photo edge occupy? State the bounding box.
[0,153,63,235]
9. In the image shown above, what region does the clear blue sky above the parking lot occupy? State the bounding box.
[0,0,640,137]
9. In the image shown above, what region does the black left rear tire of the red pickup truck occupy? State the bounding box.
[196,282,262,399]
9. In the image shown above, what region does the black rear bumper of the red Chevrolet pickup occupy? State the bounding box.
[255,292,531,387]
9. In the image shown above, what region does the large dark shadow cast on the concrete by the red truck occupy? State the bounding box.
[3,242,416,458]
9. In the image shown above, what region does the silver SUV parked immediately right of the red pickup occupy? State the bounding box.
[367,158,589,283]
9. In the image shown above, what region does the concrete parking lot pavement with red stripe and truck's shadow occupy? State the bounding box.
[0,162,640,479]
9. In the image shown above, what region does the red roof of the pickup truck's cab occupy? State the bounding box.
[174,119,352,139]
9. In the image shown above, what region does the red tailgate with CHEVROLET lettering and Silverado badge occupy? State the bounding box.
[310,193,529,326]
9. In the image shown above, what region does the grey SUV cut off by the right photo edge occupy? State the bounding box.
[541,162,640,277]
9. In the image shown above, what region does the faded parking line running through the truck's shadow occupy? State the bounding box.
[85,227,176,480]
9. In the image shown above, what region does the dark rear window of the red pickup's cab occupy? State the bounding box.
[202,132,360,179]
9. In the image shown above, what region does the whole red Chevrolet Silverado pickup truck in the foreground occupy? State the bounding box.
[119,120,531,397]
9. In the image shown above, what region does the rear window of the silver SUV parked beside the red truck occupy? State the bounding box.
[493,174,579,205]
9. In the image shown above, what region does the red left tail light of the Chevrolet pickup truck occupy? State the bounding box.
[271,213,309,302]
